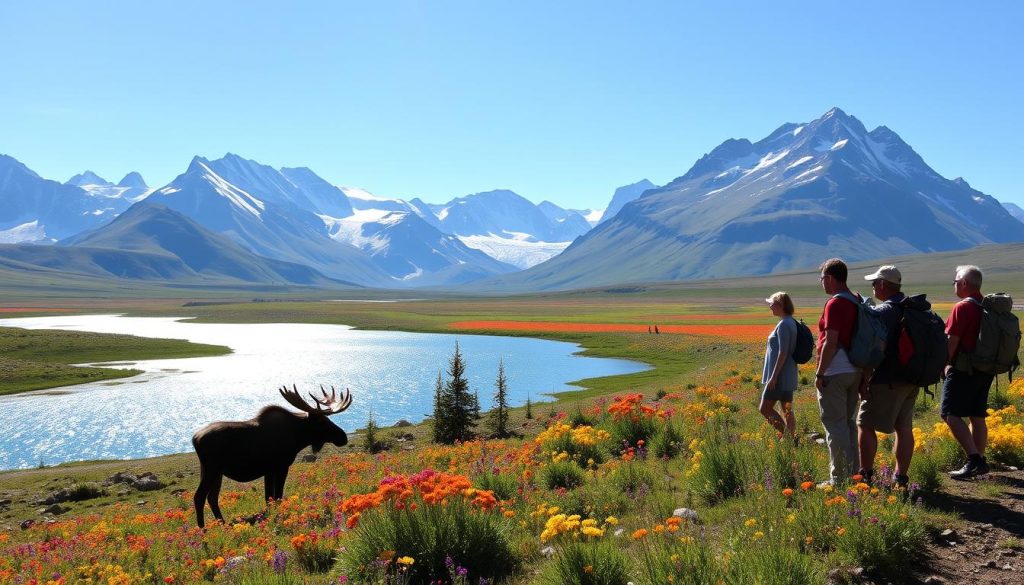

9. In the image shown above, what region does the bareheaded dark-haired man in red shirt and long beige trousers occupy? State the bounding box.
[814,258,861,485]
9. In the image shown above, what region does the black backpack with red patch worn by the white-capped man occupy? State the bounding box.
[897,294,949,387]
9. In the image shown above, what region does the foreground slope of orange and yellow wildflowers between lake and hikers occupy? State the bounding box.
[0,299,1024,585]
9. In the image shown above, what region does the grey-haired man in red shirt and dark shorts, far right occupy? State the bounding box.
[939,265,993,479]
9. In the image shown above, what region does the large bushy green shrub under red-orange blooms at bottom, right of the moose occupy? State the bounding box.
[342,499,517,583]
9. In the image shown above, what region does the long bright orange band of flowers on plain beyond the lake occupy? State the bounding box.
[450,321,774,341]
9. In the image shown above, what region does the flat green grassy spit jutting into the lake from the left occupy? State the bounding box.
[0,327,230,394]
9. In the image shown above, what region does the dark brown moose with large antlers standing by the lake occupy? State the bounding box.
[193,384,352,528]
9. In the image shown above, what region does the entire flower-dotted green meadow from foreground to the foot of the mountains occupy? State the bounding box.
[0,249,1024,585]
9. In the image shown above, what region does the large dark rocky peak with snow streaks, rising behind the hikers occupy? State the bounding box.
[481,108,1024,291]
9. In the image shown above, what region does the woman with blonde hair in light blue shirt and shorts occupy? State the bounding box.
[760,291,797,443]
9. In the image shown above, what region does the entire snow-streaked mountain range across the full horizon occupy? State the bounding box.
[0,109,1024,291]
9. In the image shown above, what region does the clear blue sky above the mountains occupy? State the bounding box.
[0,0,1024,208]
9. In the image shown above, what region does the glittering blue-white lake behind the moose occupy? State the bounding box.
[0,315,649,469]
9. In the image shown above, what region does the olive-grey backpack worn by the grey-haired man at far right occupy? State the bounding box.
[970,293,1021,378]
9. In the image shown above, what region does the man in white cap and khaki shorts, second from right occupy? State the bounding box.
[857,265,919,488]
